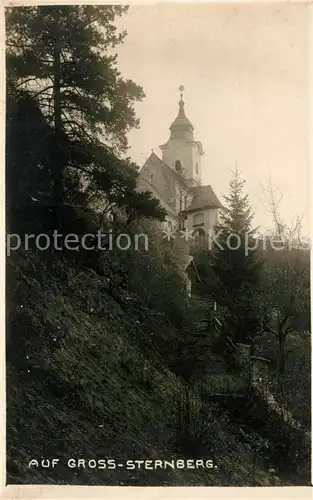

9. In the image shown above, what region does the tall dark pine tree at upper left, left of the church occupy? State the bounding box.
[6,5,164,227]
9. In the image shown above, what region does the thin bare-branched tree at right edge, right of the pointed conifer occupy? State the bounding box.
[262,181,310,379]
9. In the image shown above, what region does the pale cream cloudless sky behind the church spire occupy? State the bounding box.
[117,3,310,235]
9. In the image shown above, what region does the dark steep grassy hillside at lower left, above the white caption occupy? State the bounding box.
[7,248,306,486]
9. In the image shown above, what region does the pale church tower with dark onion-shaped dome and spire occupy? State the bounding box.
[160,85,204,187]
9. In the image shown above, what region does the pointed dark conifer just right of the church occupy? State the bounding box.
[212,168,262,342]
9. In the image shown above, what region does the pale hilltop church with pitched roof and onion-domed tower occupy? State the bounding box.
[138,86,222,248]
